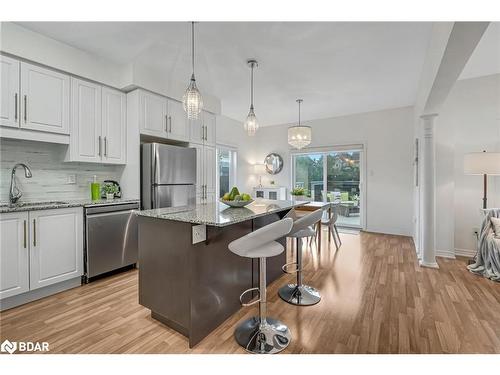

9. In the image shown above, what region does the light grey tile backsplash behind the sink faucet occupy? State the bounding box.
[0,139,123,202]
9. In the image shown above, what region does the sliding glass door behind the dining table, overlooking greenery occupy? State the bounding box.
[292,145,364,228]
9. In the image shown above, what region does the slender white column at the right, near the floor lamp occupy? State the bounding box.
[420,114,439,268]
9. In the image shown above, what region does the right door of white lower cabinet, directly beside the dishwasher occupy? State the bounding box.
[29,207,83,289]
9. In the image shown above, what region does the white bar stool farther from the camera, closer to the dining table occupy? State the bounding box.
[278,210,323,306]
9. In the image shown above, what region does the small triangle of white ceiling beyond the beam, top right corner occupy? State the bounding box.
[460,22,500,79]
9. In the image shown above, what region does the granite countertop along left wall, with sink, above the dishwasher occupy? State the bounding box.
[0,198,139,213]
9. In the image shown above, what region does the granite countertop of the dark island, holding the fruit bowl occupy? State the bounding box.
[136,199,308,227]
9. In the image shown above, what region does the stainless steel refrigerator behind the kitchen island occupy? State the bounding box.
[142,143,196,210]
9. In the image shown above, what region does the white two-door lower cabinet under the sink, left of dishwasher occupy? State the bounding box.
[0,207,83,299]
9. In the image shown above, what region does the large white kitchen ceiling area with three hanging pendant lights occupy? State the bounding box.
[15,22,438,125]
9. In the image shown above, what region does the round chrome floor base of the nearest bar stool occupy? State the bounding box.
[234,317,292,354]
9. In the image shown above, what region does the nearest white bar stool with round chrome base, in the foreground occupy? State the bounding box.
[228,218,293,354]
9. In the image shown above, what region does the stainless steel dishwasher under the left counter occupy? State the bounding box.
[84,202,139,282]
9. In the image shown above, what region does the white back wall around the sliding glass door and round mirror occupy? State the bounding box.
[241,107,413,235]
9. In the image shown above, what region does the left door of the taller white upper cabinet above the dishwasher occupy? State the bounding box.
[70,78,102,162]
